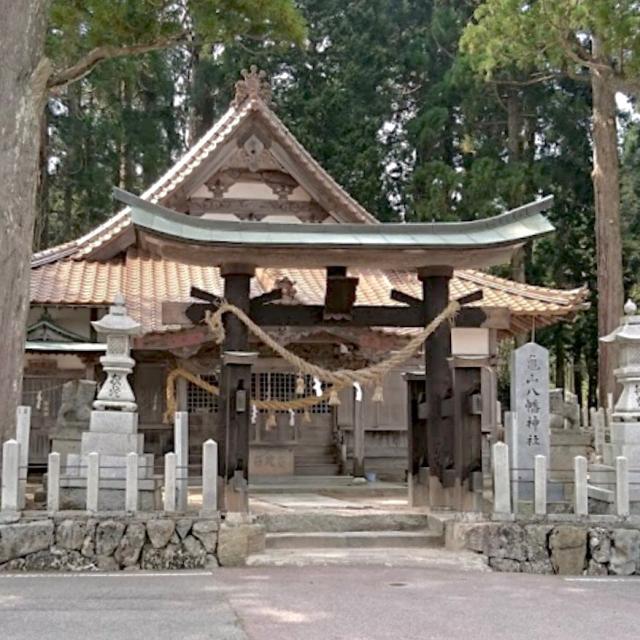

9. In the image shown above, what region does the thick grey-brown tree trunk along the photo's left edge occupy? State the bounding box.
[0,0,50,440]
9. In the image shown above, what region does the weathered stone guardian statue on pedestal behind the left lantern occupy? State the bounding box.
[50,380,98,465]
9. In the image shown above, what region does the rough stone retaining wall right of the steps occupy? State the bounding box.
[446,516,640,576]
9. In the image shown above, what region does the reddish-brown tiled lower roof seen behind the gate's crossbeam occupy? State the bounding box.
[31,250,587,333]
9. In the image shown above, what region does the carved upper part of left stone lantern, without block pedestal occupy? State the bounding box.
[91,294,141,411]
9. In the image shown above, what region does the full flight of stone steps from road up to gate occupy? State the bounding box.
[247,510,486,570]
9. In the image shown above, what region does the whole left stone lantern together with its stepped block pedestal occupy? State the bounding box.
[60,294,160,511]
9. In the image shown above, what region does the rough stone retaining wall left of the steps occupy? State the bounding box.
[0,512,264,571]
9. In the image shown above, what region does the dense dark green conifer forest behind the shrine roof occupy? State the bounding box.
[34,0,640,405]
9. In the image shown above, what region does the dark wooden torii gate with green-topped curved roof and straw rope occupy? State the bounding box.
[116,190,553,511]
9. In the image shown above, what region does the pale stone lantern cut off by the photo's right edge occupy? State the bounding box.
[600,300,640,422]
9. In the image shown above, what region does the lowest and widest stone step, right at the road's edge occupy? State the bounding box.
[247,548,484,572]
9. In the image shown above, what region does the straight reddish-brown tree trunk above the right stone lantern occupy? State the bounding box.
[591,39,623,406]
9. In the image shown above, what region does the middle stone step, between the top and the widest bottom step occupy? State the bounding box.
[266,530,443,549]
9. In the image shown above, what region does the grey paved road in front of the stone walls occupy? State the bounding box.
[0,567,640,640]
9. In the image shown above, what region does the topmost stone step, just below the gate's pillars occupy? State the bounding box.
[258,509,444,536]
